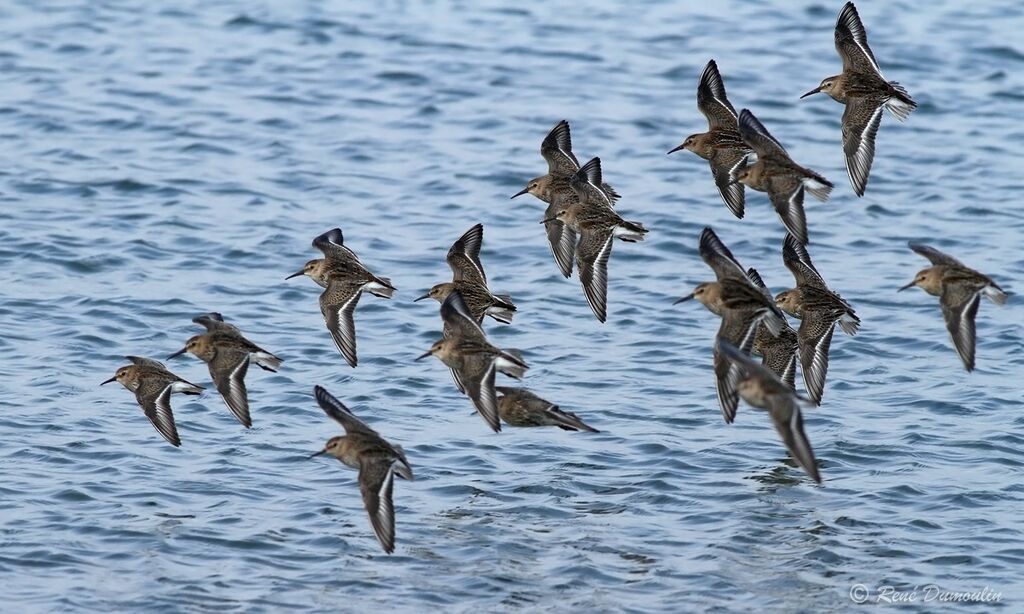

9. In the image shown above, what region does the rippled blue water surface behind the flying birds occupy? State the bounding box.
[0,0,1024,612]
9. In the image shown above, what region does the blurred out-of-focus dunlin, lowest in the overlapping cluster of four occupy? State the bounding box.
[718,340,821,484]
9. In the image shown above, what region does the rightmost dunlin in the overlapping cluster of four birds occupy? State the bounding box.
[775,234,860,405]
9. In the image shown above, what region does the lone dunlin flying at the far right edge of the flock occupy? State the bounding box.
[899,242,1007,371]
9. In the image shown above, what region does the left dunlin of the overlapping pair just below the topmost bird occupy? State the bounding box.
[669,59,752,218]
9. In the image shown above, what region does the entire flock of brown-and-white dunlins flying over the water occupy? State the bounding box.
[103,2,1007,553]
